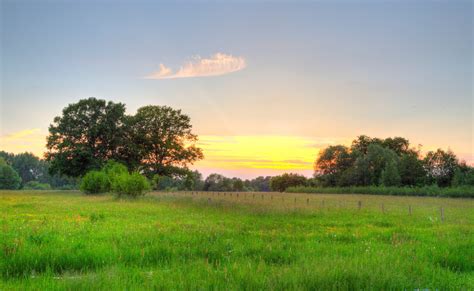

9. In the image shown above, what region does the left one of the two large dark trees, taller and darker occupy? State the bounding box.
[46,97,125,177]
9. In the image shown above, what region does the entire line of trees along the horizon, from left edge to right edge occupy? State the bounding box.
[0,97,474,196]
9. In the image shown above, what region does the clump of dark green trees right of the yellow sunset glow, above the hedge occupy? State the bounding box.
[312,135,468,187]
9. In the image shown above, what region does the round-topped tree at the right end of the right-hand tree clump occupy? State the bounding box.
[423,149,458,187]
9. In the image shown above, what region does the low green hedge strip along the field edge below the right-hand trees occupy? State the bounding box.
[286,185,474,198]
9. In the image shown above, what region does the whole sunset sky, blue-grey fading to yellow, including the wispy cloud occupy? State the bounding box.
[0,0,474,178]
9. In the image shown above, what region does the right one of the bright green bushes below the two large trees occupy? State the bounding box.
[112,172,151,197]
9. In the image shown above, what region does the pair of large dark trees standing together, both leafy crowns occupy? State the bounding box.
[46,97,203,177]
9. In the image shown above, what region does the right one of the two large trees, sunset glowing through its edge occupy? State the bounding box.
[130,106,203,177]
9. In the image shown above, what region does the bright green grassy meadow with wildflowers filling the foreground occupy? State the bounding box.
[0,191,474,290]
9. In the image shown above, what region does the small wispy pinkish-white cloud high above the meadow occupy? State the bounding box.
[145,53,247,79]
